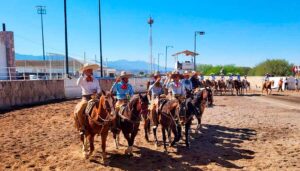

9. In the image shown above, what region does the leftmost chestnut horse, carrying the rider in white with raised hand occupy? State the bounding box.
[74,91,115,162]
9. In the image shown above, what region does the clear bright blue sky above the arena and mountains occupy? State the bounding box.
[0,0,300,66]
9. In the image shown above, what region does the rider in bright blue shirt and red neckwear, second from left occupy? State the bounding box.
[111,71,134,129]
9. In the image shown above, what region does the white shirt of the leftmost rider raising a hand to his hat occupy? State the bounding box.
[77,76,101,95]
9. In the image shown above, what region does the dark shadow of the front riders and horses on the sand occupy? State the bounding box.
[93,125,256,170]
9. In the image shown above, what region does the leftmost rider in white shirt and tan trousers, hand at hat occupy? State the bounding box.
[75,63,101,135]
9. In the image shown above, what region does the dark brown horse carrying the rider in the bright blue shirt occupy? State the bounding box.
[113,94,149,155]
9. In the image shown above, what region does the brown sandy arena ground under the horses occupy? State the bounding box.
[0,95,300,171]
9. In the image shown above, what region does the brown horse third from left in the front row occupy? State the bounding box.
[150,98,180,152]
